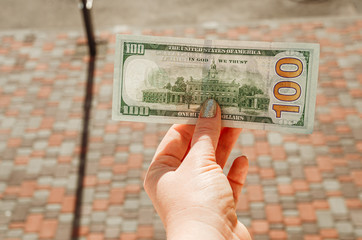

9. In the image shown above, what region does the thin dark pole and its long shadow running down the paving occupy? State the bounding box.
[71,0,97,240]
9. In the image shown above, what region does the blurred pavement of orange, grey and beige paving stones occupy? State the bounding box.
[0,17,362,240]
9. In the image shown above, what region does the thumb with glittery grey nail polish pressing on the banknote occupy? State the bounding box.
[191,99,221,157]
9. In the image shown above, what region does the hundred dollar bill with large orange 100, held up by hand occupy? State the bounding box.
[112,35,319,133]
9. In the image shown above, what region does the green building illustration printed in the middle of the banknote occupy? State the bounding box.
[142,61,269,111]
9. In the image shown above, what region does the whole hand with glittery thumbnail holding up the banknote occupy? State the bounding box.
[144,99,251,240]
